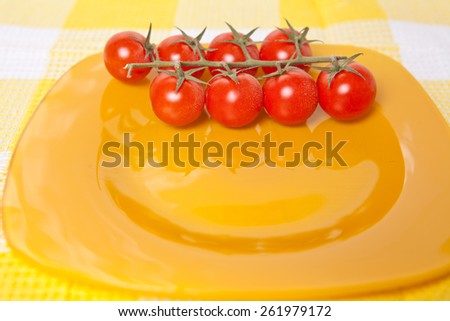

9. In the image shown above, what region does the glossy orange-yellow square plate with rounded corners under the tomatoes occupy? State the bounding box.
[3,45,450,299]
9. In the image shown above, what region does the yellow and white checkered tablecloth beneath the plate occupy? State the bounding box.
[0,0,450,300]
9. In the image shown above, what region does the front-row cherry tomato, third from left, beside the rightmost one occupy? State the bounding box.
[263,69,318,125]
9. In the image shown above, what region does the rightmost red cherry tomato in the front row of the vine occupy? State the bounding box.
[317,61,377,120]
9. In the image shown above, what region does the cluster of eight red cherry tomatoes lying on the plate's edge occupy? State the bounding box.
[104,28,376,127]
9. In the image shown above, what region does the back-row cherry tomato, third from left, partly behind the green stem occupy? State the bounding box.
[206,32,259,76]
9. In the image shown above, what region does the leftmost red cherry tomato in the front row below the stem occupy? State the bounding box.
[150,73,205,126]
